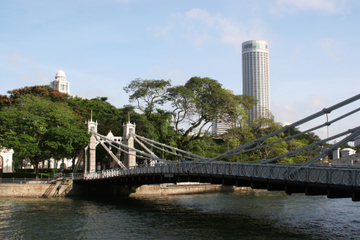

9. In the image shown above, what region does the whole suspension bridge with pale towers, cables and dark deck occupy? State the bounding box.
[74,94,360,201]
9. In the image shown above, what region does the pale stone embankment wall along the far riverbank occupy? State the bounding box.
[0,182,251,198]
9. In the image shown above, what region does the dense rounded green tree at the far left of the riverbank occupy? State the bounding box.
[0,96,89,177]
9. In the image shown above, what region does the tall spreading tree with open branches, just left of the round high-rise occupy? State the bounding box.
[165,77,254,148]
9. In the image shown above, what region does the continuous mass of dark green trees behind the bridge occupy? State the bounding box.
[0,77,326,172]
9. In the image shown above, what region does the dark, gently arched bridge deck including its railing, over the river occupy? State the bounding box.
[73,162,360,201]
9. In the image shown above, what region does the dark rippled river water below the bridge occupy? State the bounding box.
[0,191,360,239]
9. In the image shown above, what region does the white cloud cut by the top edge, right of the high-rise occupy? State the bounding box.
[271,0,348,14]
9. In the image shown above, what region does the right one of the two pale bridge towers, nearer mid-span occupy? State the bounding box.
[123,116,136,167]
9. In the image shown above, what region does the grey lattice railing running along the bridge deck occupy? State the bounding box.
[84,162,360,186]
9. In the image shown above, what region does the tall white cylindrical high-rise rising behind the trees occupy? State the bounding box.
[242,40,270,121]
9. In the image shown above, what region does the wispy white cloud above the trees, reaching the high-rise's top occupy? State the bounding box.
[148,8,266,50]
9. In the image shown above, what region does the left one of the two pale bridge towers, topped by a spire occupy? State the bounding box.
[84,113,98,173]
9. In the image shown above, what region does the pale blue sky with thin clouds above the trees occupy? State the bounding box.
[0,0,360,140]
